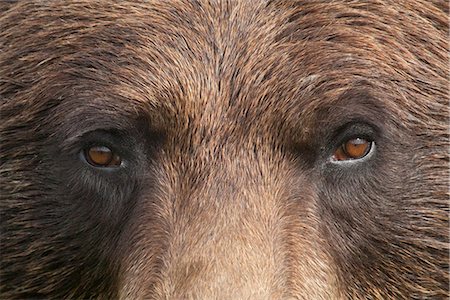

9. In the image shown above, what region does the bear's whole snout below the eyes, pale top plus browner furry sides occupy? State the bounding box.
[120,144,337,299]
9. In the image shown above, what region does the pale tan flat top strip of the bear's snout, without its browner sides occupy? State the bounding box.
[157,153,292,298]
